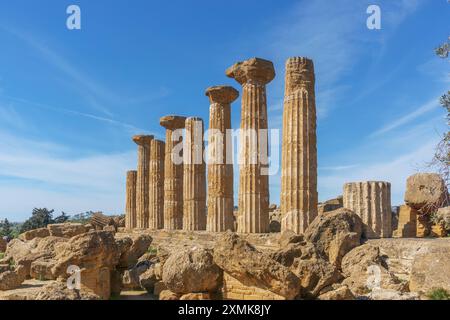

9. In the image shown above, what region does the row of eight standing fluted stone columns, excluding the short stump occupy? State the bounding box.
[126,58,317,233]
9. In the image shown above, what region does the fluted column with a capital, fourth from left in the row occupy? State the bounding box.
[160,116,186,230]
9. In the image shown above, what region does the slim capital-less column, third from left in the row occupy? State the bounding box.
[149,140,166,230]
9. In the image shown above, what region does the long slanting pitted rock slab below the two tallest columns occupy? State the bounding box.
[214,231,301,299]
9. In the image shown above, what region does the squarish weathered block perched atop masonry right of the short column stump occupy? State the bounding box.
[405,173,448,214]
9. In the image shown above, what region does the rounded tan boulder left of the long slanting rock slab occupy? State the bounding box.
[162,247,222,294]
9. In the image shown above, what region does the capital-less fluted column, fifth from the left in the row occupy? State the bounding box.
[183,117,206,231]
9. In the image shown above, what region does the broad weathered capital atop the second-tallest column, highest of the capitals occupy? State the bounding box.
[225,58,275,85]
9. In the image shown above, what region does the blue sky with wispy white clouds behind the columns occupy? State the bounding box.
[0,0,450,221]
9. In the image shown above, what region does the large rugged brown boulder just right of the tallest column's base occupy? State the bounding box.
[304,209,363,268]
